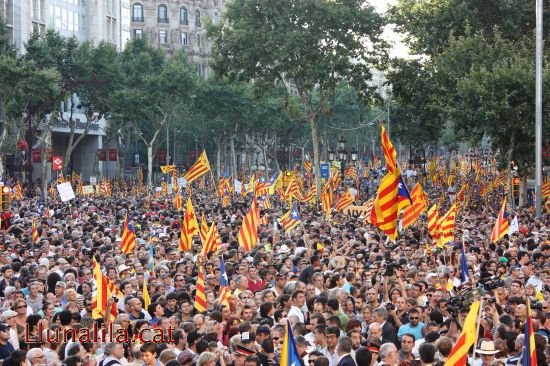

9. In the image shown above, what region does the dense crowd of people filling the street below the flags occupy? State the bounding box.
[0,172,550,366]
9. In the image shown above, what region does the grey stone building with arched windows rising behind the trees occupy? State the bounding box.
[130,0,225,77]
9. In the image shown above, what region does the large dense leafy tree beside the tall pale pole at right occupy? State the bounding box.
[388,0,550,183]
